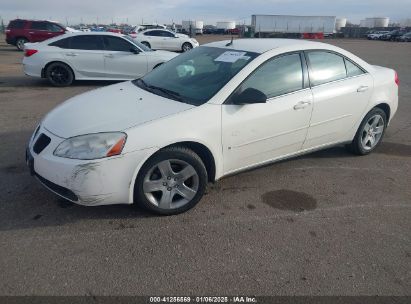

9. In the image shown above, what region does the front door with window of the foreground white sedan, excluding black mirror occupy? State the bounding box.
[222,53,313,174]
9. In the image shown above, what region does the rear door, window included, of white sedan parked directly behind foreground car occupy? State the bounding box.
[62,35,105,79]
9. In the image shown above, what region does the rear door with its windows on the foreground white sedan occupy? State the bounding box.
[303,50,374,148]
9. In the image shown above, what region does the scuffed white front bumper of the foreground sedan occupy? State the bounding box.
[26,128,156,206]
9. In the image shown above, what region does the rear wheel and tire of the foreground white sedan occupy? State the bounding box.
[347,108,387,155]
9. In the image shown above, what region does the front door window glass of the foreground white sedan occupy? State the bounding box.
[236,54,304,98]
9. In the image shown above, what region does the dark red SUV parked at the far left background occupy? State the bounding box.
[6,19,67,51]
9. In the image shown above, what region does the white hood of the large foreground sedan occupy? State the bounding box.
[42,81,194,138]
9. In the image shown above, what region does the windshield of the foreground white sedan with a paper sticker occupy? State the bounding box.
[133,46,259,106]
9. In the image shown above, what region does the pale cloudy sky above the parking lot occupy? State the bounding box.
[0,0,411,25]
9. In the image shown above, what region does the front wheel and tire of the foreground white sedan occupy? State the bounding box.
[134,146,208,215]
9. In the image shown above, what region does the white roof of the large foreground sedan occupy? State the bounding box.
[204,38,332,54]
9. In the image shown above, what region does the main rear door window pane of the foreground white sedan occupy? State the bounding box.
[308,51,347,86]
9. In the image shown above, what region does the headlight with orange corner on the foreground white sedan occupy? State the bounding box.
[54,132,127,159]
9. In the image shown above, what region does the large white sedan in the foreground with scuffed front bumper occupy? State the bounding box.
[27,39,399,214]
